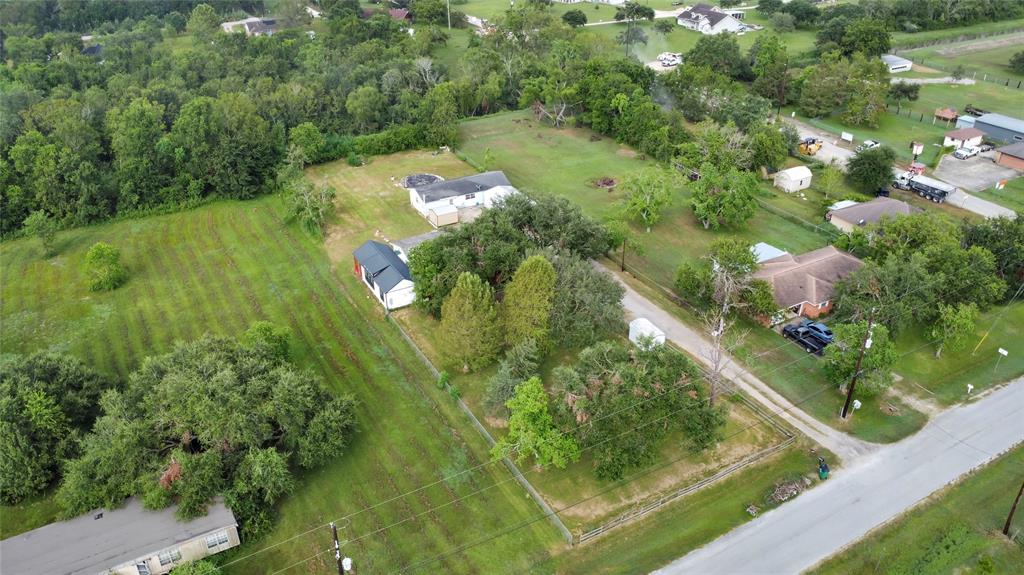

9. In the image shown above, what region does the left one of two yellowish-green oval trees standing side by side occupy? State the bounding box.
[437,272,502,371]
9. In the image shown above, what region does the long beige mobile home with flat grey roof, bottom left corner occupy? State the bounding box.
[0,498,239,575]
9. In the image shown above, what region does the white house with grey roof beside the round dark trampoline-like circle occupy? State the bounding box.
[409,172,518,227]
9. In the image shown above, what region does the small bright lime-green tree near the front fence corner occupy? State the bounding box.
[490,378,580,469]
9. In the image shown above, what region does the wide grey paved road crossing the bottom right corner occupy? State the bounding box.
[655,378,1024,575]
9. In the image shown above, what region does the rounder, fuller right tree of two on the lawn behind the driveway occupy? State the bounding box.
[690,164,758,229]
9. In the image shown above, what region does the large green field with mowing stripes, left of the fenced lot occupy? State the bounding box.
[0,191,558,574]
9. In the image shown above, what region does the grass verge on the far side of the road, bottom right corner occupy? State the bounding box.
[813,447,1024,575]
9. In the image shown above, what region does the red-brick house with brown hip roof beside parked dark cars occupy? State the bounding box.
[754,246,863,321]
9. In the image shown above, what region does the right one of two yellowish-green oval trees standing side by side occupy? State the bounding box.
[502,255,556,350]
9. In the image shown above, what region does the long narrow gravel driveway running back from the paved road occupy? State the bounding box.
[594,263,879,459]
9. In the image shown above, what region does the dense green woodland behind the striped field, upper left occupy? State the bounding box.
[0,3,459,233]
